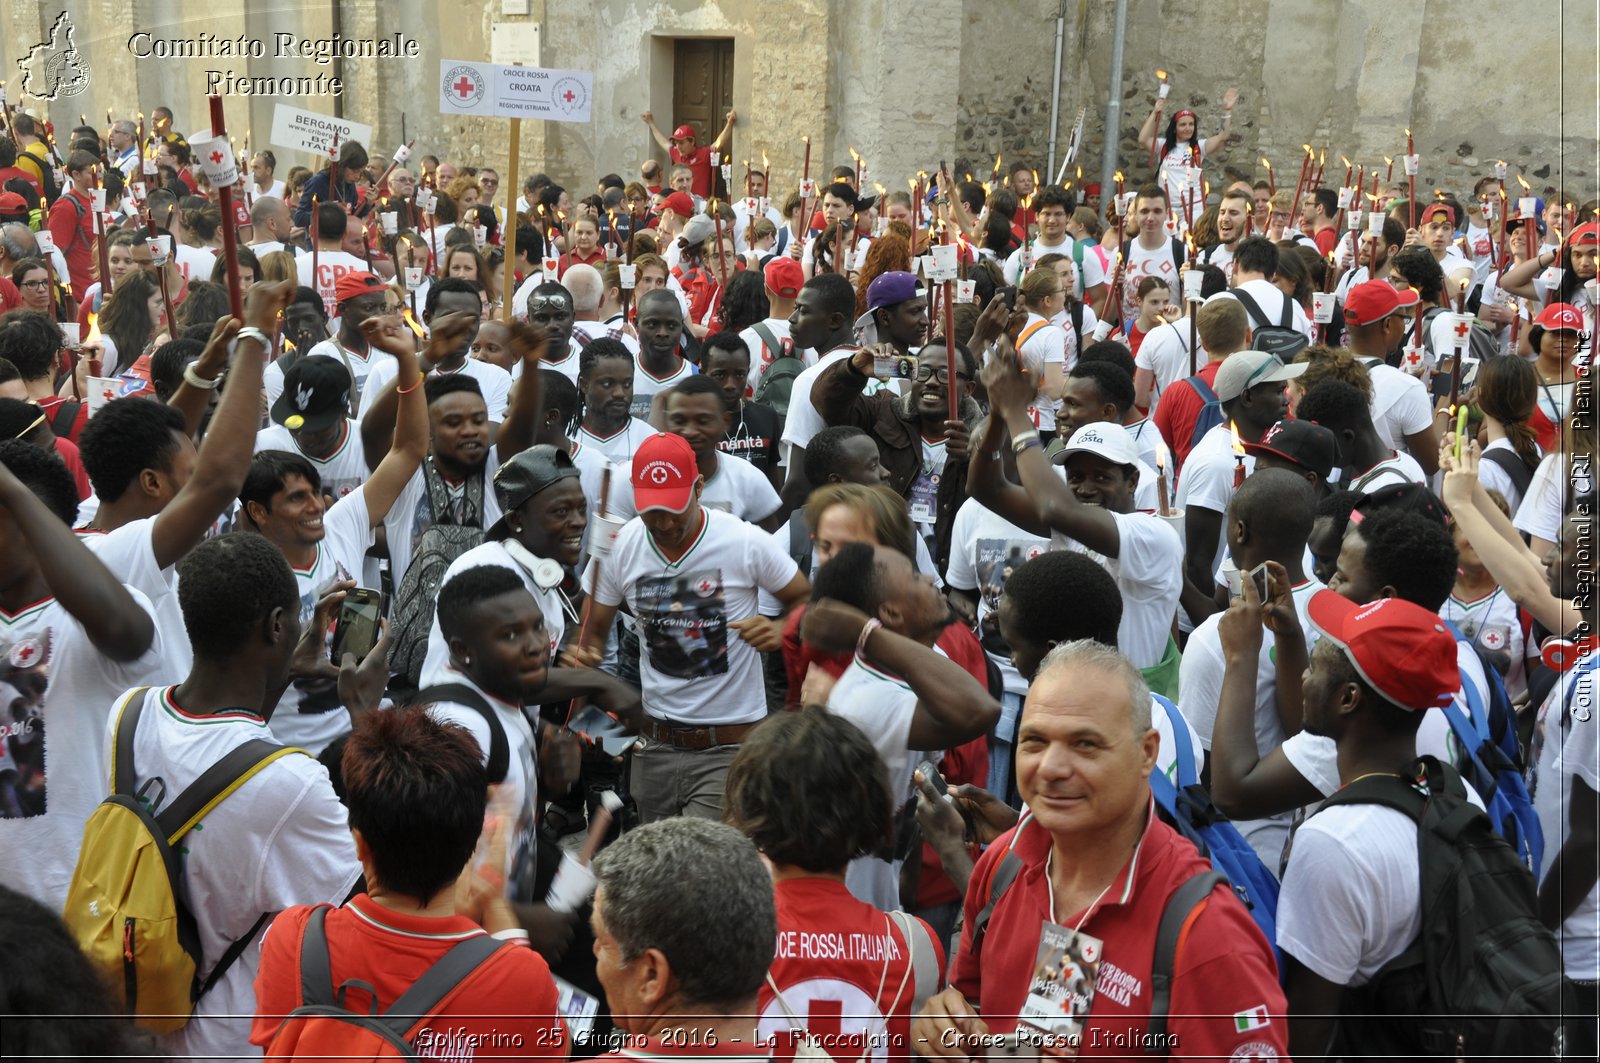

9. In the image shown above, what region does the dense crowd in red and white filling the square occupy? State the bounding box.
[0,91,1600,1061]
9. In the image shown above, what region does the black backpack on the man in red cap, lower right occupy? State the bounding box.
[1322,757,1578,1060]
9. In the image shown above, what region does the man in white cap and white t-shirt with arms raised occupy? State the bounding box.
[966,339,1182,695]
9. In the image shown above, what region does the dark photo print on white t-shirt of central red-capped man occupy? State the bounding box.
[638,568,728,679]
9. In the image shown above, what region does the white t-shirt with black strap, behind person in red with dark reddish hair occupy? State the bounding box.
[427,668,539,905]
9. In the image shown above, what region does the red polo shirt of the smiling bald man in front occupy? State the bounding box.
[950,800,1288,1060]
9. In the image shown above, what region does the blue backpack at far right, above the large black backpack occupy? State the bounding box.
[1445,621,1544,874]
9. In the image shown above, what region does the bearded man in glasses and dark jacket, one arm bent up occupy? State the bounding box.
[816,321,979,557]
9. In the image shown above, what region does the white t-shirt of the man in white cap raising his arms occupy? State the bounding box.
[1050,511,1184,668]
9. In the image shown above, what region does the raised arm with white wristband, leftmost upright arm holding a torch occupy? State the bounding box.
[150,280,294,568]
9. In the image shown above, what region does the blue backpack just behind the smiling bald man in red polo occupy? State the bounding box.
[1150,693,1283,972]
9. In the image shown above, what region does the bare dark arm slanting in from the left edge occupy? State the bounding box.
[0,463,155,661]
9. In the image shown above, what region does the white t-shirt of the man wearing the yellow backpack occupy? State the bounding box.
[119,687,362,1058]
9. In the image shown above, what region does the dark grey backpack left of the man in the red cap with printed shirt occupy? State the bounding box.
[389,459,485,688]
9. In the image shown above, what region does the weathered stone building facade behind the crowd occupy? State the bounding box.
[0,0,1600,200]
